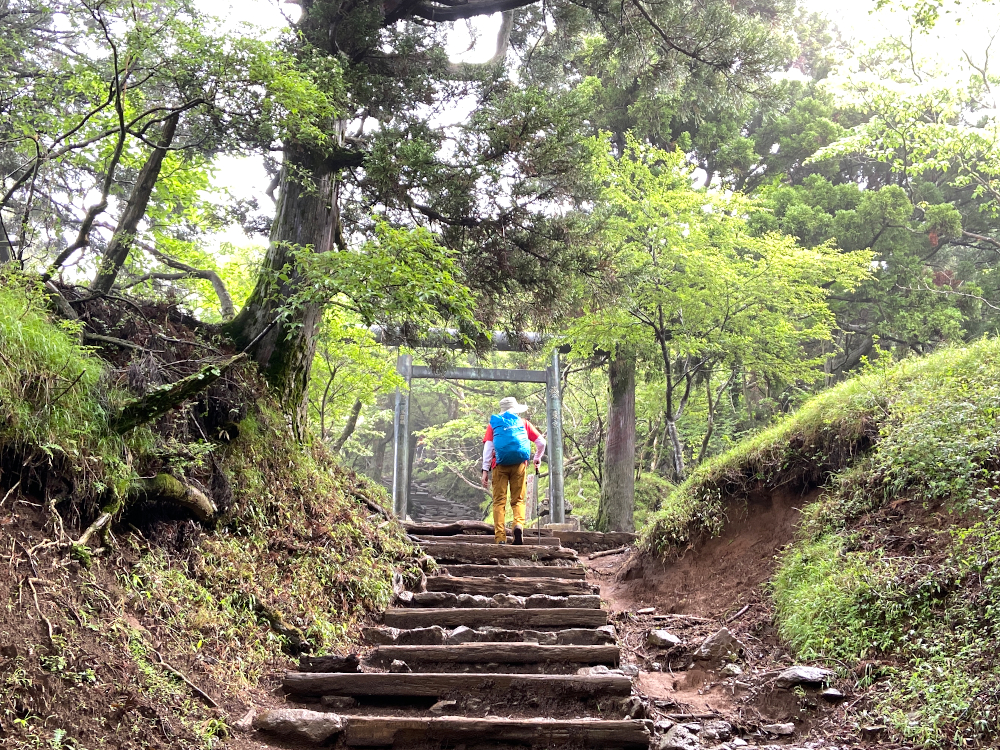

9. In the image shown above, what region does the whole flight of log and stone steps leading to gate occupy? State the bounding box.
[270,521,652,750]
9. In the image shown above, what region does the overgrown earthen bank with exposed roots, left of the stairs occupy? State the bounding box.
[0,277,421,750]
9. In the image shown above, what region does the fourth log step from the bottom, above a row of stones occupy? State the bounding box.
[383,607,608,630]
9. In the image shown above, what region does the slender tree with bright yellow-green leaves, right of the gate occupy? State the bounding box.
[573,140,871,479]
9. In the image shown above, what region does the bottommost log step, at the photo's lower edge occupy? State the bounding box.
[343,716,651,749]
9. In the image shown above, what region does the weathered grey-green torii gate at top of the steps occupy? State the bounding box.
[371,326,566,523]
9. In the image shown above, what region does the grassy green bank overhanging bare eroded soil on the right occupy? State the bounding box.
[643,339,1000,748]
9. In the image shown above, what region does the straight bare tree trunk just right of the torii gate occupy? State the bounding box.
[597,347,635,531]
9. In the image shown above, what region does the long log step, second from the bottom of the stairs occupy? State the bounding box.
[282,672,632,698]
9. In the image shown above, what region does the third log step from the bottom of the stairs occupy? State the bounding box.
[370,643,618,668]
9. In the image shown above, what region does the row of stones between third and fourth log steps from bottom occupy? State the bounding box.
[364,625,615,648]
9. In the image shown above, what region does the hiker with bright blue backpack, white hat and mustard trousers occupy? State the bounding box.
[483,396,545,544]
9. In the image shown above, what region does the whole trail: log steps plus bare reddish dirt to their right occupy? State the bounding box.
[237,506,876,750]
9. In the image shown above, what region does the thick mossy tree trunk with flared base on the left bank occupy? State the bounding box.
[226,146,339,439]
